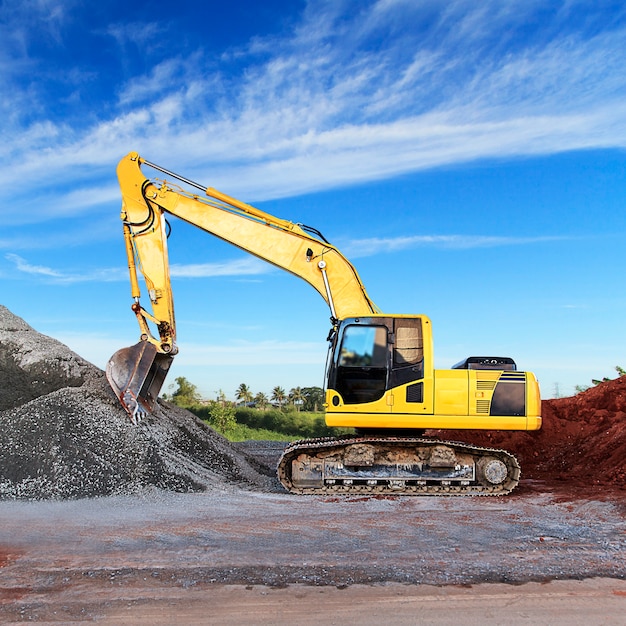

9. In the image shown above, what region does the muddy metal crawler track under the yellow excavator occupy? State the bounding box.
[278,436,520,496]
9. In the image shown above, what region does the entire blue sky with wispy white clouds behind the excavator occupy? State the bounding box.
[0,0,626,397]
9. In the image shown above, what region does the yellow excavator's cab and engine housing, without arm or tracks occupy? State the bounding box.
[326,315,541,430]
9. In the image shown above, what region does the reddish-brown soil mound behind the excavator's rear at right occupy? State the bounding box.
[426,376,626,488]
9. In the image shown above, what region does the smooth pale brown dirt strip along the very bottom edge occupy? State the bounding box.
[3,579,626,626]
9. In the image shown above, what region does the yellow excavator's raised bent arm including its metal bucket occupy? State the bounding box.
[107,153,380,421]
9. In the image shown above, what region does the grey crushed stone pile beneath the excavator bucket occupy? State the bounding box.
[0,305,273,499]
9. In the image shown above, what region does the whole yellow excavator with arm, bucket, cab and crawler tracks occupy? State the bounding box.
[106,152,541,495]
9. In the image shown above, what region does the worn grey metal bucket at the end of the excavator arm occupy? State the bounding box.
[106,341,174,424]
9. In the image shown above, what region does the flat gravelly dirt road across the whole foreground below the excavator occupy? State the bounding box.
[0,483,626,624]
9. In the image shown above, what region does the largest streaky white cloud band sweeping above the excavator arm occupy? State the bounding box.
[0,0,626,215]
